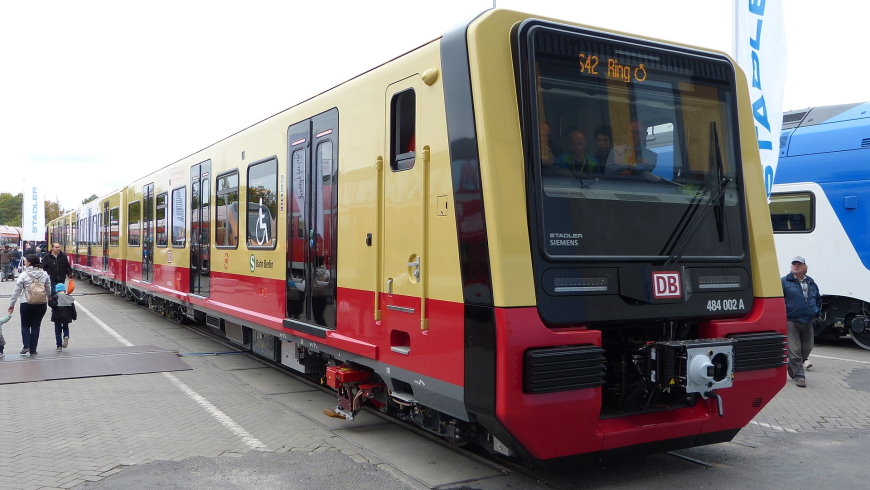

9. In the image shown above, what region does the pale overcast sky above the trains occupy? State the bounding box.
[0,0,870,208]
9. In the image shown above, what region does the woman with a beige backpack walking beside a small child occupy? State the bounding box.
[9,254,51,356]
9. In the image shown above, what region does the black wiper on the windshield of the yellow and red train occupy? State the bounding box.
[664,121,734,265]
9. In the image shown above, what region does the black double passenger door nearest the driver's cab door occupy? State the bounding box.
[286,109,338,329]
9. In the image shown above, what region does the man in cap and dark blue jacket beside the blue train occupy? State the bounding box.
[782,256,822,388]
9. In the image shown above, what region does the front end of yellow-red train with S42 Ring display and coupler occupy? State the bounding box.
[456,11,785,460]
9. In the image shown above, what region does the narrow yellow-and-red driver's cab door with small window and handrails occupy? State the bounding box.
[380,76,426,334]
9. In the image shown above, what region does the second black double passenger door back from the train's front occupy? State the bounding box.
[190,160,211,296]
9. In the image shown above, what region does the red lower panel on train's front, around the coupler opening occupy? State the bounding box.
[495,298,785,459]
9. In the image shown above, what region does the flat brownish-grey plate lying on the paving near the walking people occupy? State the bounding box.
[0,345,191,384]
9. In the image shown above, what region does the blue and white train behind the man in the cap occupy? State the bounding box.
[770,102,870,349]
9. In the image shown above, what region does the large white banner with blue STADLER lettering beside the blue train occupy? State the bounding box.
[734,0,786,196]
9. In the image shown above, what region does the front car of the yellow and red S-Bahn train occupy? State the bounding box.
[51,10,785,461]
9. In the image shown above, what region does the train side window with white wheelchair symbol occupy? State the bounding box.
[245,158,278,249]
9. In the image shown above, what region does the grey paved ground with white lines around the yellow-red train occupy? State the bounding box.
[0,282,870,490]
